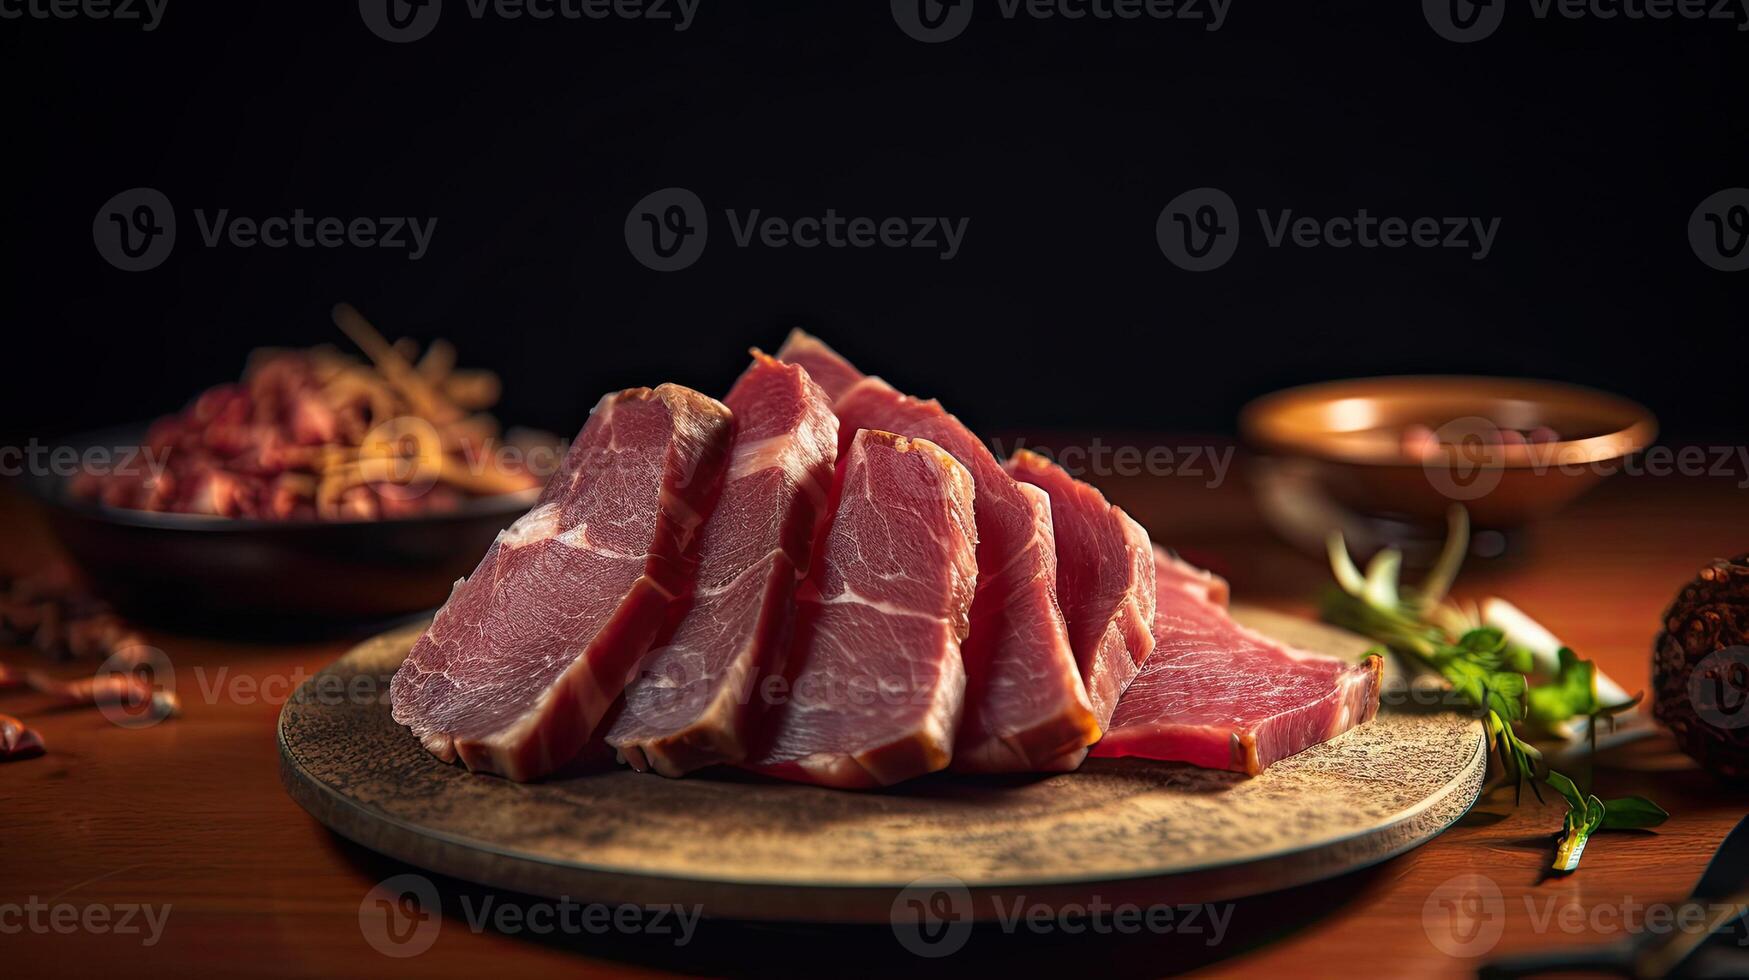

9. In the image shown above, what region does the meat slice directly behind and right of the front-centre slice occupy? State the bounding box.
[836,378,1100,772]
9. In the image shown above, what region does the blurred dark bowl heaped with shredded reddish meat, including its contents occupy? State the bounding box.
[18,308,563,634]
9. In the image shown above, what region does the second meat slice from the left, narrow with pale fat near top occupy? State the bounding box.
[607,352,838,775]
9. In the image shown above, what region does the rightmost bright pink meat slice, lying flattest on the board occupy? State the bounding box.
[1093,548,1383,775]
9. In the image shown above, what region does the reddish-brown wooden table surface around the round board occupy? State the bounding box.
[0,455,1749,978]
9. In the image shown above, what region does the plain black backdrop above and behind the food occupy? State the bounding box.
[0,0,1749,439]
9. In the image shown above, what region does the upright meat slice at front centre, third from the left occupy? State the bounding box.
[749,431,978,789]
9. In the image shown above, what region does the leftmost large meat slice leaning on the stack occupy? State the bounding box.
[390,385,733,781]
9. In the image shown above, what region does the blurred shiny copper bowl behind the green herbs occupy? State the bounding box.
[1240,376,1658,529]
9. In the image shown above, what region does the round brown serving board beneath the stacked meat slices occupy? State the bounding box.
[280,607,1487,922]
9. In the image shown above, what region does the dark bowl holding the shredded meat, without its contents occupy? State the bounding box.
[26,429,539,635]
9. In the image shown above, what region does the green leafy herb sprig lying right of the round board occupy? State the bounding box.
[1322,508,1670,872]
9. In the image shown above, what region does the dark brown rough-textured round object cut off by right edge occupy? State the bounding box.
[1651,555,1749,779]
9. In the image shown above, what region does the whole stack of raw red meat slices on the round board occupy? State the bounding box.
[392,331,1380,788]
